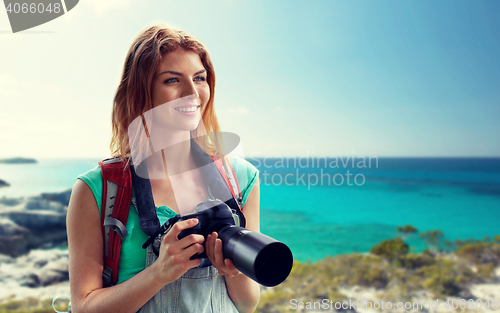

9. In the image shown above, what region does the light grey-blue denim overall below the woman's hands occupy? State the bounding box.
[139,246,238,313]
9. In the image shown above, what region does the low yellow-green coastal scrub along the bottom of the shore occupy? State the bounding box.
[0,225,500,313]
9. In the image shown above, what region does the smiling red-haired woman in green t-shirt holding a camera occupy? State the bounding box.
[67,26,259,313]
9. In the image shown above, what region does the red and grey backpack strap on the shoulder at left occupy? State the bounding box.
[99,157,132,287]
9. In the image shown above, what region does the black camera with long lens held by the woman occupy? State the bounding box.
[146,200,293,287]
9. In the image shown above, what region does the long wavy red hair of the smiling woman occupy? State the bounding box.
[110,25,220,160]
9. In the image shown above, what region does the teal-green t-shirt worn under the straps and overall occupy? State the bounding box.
[78,156,259,284]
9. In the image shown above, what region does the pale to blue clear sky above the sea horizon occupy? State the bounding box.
[0,0,500,158]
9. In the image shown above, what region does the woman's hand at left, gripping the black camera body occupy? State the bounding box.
[151,218,205,285]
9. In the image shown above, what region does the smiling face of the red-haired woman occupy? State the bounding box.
[153,49,210,131]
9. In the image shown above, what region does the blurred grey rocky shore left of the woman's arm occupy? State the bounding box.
[0,190,71,302]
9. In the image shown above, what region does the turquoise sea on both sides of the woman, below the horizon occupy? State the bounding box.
[0,156,500,262]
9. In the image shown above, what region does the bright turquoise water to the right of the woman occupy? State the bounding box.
[254,158,500,261]
